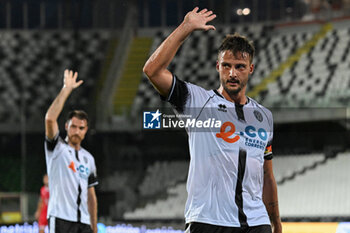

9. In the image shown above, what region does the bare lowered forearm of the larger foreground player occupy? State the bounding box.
[263,159,282,233]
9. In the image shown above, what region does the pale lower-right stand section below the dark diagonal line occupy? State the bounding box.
[278,152,350,217]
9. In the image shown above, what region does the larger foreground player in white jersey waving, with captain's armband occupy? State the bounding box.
[143,7,282,233]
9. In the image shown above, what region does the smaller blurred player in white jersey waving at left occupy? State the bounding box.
[45,70,98,233]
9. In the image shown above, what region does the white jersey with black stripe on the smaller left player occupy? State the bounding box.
[45,134,98,224]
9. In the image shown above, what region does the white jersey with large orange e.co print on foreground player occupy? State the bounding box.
[164,76,273,227]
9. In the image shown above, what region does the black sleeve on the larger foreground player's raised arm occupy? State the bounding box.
[160,75,189,112]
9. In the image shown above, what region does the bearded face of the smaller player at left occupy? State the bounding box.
[66,117,88,145]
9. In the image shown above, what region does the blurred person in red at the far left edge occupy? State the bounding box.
[35,174,50,233]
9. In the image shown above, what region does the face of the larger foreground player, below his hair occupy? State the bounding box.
[216,50,254,96]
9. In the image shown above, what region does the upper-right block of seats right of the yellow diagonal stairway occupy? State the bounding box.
[263,25,350,107]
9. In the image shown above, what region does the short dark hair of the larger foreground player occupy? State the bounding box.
[218,32,255,63]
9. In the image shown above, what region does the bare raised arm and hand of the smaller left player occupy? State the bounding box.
[45,70,83,140]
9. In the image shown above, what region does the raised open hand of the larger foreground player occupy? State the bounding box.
[184,7,216,31]
